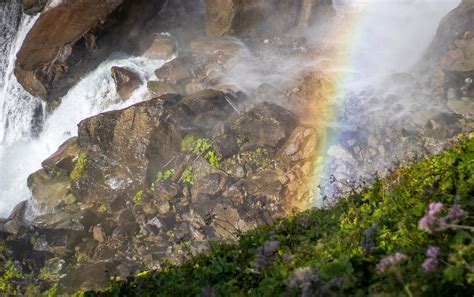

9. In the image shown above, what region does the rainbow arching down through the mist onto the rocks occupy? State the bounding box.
[308,5,380,207]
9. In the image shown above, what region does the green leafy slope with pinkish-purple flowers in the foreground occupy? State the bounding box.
[80,135,474,296]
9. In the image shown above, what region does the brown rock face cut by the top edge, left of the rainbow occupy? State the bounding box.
[205,0,332,37]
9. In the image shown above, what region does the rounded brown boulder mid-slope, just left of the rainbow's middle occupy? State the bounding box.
[233,103,296,147]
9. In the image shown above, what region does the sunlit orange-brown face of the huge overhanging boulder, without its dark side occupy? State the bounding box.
[15,0,122,99]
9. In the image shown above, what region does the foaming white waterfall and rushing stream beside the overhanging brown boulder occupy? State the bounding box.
[0,1,169,217]
